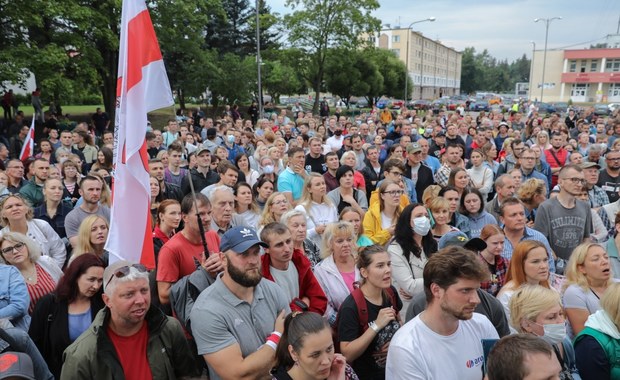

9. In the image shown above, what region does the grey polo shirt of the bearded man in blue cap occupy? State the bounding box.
[190,274,291,380]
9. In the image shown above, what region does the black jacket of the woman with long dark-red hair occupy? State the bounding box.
[28,293,105,379]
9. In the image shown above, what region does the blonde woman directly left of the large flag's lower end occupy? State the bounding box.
[69,215,110,266]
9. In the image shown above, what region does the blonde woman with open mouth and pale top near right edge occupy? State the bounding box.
[562,243,613,336]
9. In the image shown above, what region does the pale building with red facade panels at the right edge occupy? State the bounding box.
[530,45,620,103]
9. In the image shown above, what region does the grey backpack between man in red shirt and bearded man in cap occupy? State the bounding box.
[169,259,215,334]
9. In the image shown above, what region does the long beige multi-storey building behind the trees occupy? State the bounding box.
[369,28,462,99]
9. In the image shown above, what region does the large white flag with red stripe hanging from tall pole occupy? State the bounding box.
[105,0,174,268]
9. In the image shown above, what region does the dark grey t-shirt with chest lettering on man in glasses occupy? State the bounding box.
[534,198,592,260]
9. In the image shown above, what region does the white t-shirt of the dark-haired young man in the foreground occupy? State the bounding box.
[385,313,499,380]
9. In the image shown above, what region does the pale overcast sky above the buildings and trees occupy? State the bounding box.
[268,0,620,61]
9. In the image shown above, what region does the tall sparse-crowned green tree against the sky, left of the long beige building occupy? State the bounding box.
[284,0,380,112]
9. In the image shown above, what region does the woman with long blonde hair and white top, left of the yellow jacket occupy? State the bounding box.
[295,173,338,246]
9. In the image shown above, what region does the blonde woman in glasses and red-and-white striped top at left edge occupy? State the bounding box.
[0,232,62,314]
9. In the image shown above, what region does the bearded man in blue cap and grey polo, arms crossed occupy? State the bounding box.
[190,226,290,380]
